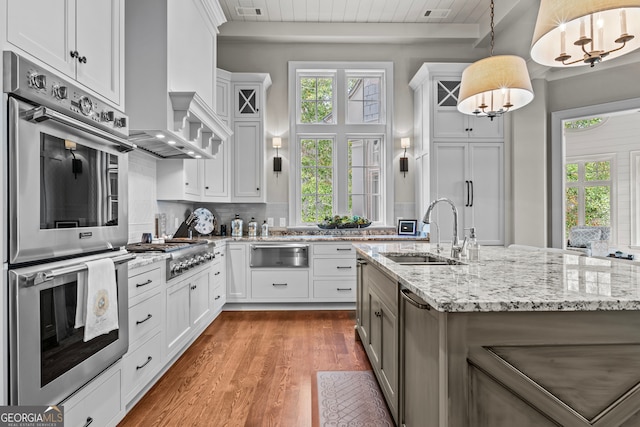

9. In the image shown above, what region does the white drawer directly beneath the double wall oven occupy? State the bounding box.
[62,369,122,427]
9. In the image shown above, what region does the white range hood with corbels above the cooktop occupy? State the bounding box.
[124,0,233,159]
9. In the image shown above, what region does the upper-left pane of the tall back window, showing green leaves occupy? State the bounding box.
[298,74,335,124]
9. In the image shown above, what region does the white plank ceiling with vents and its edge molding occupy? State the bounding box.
[220,0,540,47]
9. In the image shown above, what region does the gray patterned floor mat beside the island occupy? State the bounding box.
[317,371,394,427]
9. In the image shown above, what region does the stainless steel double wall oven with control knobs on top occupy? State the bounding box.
[3,52,133,405]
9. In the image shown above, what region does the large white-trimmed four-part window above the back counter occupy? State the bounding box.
[289,62,393,225]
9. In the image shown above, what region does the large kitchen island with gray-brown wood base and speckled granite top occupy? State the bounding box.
[354,242,640,427]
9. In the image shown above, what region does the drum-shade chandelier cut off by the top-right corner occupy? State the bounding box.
[531,0,640,67]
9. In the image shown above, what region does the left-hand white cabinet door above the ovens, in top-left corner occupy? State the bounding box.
[7,0,76,78]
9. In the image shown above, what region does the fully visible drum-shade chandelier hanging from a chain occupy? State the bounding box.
[458,0,533,120]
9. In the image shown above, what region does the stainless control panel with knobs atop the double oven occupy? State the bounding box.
[3,51,129,138]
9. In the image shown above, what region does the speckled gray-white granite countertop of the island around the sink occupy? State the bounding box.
[354,242,640,312]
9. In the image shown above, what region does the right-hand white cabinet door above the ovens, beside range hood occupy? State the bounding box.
[76,0,124,104]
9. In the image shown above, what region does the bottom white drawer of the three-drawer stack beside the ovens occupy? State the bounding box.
[123,332,162,403]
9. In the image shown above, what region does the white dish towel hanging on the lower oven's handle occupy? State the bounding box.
[75,258,119,342]
